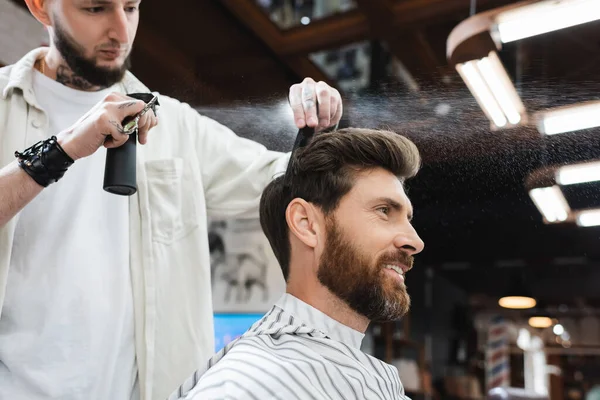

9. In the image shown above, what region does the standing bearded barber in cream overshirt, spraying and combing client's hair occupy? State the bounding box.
[0,0,342,400]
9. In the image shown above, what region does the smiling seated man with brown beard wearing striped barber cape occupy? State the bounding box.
[171,128,423,400]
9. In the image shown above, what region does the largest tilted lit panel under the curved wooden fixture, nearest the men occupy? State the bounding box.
[456,51,525,128]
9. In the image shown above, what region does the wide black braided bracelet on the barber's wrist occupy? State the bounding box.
[15,136,75,187]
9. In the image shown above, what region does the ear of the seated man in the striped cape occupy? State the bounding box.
[285,198,323,248]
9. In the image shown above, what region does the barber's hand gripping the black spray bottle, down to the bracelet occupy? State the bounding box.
[56,93,158,160]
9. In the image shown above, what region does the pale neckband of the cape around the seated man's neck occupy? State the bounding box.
[275,293,365,349]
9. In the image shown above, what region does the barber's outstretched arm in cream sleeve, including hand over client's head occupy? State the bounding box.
[192,78,342,218]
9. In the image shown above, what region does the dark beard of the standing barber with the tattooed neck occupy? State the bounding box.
[54,18,131,88]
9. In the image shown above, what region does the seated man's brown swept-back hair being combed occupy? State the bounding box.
[260,128,421,281]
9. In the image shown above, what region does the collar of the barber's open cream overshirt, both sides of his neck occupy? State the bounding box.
[2,47,150,101]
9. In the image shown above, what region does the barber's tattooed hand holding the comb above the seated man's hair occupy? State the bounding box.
[289,78,343,132]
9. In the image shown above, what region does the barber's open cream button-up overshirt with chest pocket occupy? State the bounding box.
[0,48,289,400]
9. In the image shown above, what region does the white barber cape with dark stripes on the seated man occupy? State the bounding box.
[168,294,410,400]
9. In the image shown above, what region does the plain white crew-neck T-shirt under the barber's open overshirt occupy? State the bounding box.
[0,71,139,400]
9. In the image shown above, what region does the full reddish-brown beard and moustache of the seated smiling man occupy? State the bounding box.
[317,219,413,322]
